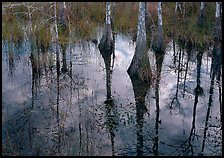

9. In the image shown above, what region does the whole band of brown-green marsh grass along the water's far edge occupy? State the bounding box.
[2,2,215,48]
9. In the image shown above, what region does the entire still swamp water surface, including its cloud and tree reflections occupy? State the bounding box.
[2,27,222,156]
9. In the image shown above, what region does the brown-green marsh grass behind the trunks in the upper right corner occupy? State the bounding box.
[163,3,215,47]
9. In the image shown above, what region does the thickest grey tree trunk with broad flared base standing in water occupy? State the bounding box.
[127,2,151,83]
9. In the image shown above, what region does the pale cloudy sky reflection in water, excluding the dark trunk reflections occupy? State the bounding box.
[2,31,222,155]
